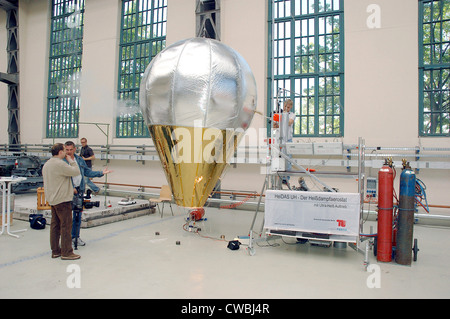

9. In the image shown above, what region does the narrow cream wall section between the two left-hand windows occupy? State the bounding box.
[79,0,121,145]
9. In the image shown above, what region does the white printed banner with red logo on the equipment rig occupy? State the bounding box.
[264,190,360,236]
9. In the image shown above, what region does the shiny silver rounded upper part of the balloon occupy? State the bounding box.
[140,38,256,130]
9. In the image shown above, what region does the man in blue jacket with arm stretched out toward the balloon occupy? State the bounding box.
[64,141,112,246]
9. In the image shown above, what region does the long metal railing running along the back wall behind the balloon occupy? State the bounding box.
[0,144,450,171]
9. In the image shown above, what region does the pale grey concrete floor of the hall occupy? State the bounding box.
[0,194,450,299]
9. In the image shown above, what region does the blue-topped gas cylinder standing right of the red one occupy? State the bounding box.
[395,165,416,265]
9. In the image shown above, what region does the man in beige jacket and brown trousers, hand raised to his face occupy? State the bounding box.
[42,143,80,260]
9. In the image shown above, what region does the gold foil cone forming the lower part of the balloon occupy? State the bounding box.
[149,125,242,208]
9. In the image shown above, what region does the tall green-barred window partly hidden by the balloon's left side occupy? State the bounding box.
[116,0,167,137]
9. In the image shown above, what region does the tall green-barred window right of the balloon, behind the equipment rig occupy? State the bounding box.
[268,0,344,137]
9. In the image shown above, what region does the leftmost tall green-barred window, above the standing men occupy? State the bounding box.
[46,0,84,138]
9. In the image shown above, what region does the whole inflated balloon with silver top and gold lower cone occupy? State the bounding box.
[140,38,256,208]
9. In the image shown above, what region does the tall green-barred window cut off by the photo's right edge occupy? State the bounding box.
[419,0,450,136]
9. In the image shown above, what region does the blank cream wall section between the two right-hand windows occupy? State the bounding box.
[345,0,419,146]
